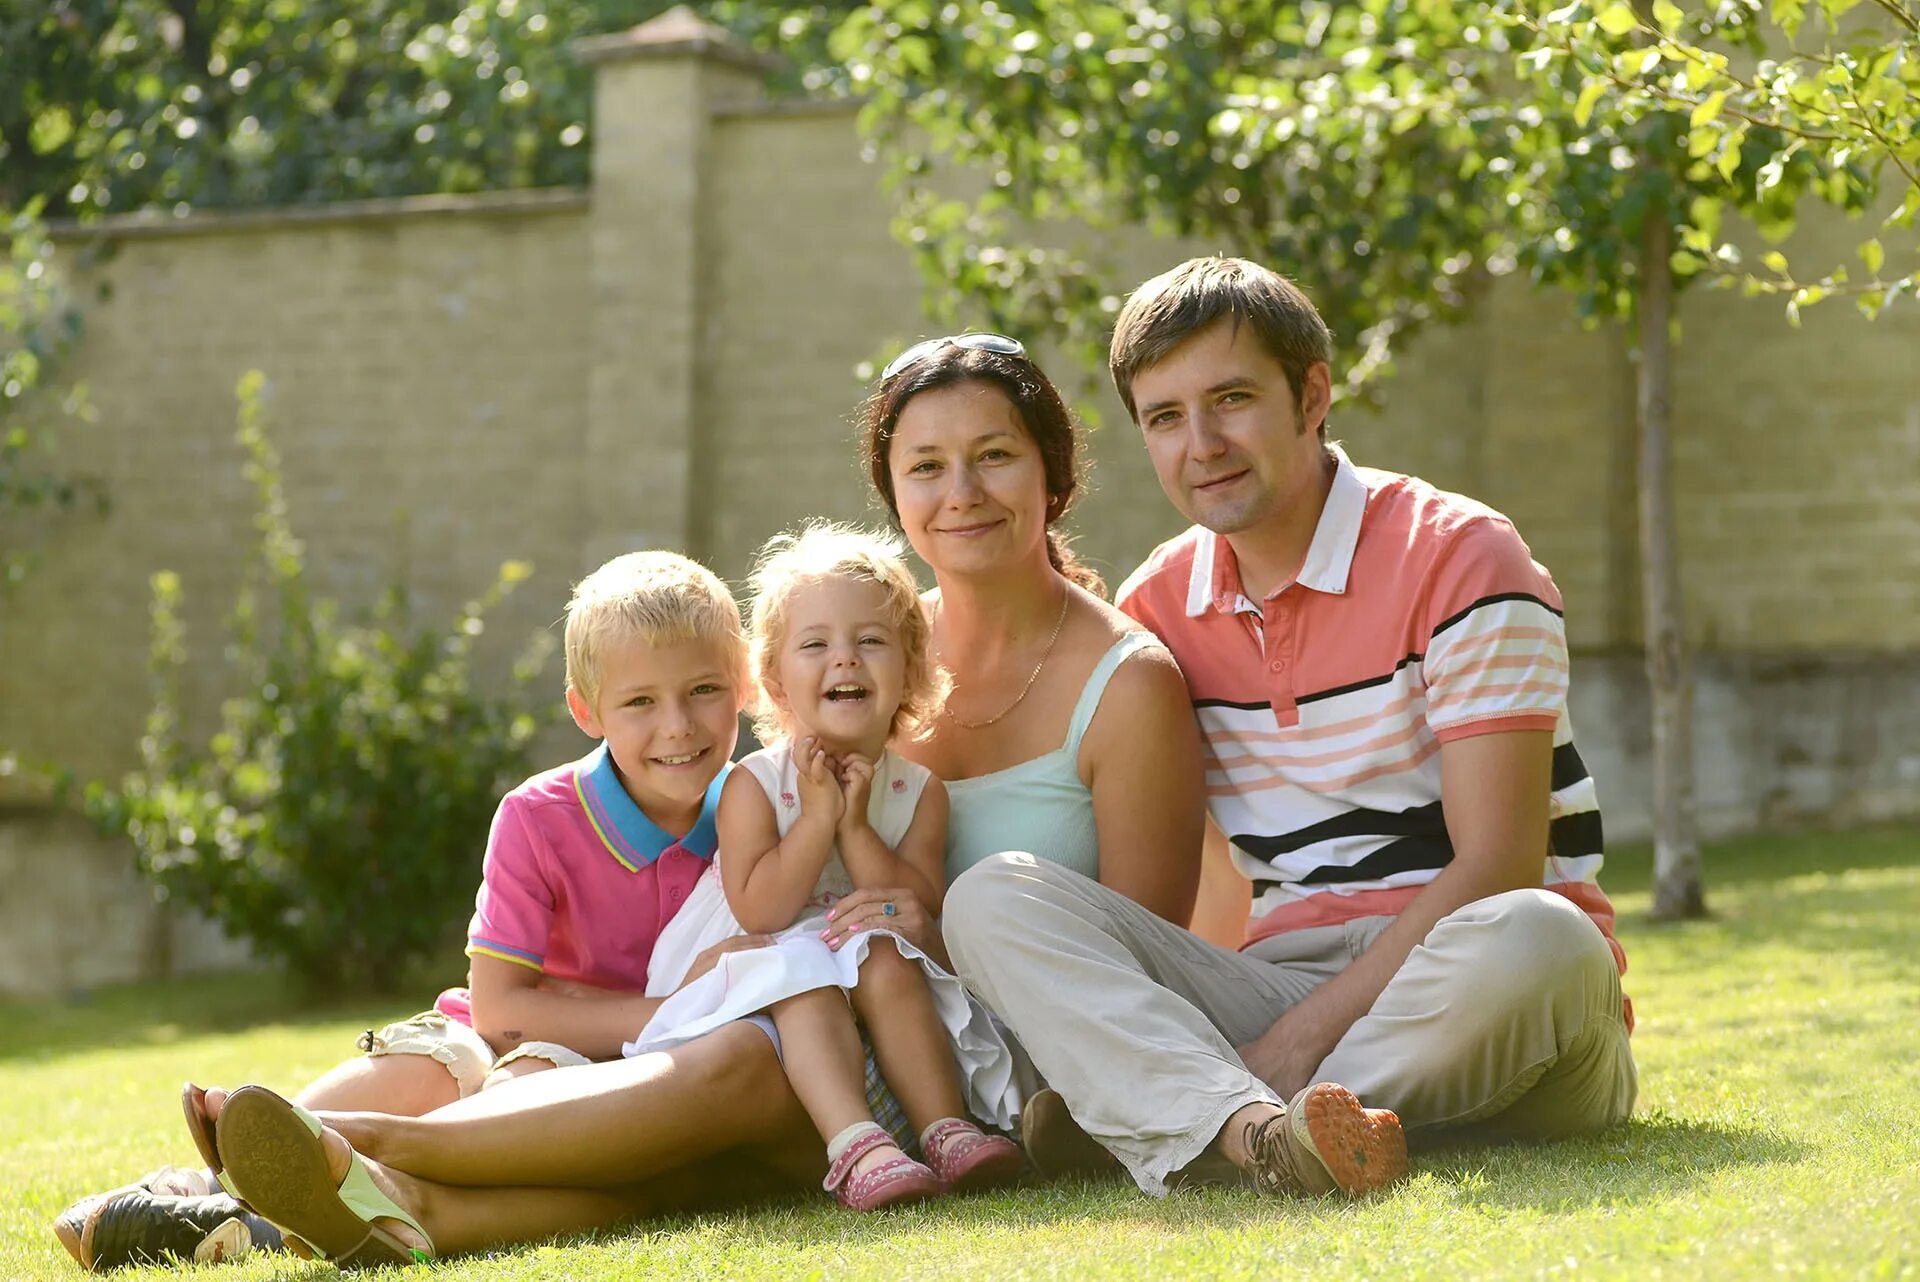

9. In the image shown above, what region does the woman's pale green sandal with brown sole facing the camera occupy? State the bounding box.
[215,1086,434,1269]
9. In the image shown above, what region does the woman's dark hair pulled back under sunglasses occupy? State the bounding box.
[860,344,1106,597]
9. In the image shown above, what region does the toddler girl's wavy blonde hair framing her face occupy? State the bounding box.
[749,520,947,743]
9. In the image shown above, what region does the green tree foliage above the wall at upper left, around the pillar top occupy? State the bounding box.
[0,0,847,217]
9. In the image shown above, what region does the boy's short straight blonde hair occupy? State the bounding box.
[566,553,747,706]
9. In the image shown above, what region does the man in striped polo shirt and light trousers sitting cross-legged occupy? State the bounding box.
[945,257,1636,1194]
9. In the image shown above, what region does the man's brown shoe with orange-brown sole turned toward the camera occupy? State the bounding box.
[1246,1082,1407,1198]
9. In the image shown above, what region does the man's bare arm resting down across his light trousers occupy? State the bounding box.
[1240,729,1553,1100]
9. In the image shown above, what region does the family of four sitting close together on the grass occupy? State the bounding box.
[54,257,1636,1269]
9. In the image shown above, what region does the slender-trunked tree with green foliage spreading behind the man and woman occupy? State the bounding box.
[833,0,1920,915]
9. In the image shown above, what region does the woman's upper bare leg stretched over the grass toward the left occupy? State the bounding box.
[323,1023,826,1189]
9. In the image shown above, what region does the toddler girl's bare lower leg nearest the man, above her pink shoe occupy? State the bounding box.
[849,938,966,1132]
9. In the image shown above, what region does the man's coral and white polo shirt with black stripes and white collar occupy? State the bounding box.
[1119,447,1626,971]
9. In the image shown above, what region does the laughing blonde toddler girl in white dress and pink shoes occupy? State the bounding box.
[626,526,1021,1211]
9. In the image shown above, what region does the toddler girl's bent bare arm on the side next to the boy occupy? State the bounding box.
[714,759,839,933]
